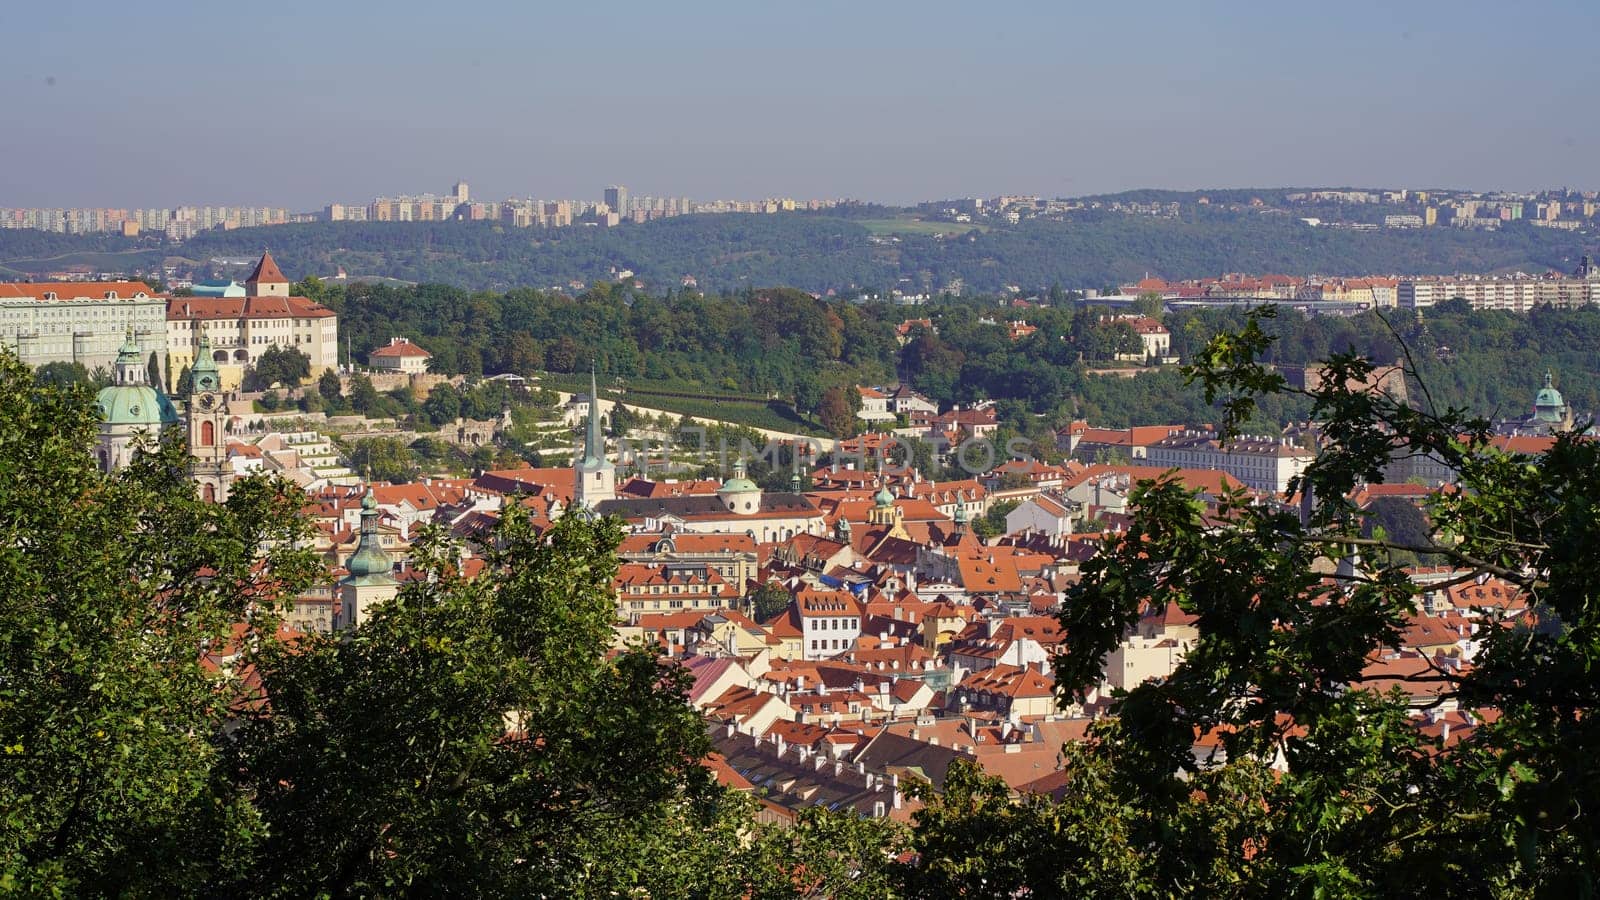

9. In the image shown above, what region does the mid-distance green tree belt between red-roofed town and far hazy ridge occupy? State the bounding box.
[299,280,1600,434]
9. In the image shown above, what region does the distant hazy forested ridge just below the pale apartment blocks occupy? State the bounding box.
[0,210,1592,291]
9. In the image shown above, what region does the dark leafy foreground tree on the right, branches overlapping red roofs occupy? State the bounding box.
[909,305,1600,897]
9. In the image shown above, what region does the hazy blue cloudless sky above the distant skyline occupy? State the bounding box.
[0,0,1600,210]
